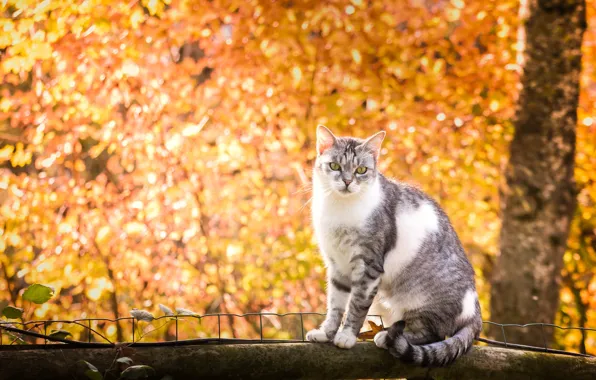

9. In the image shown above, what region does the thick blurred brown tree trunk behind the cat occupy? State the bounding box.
[490,0,586,346]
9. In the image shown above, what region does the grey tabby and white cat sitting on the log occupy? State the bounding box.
[306,125,482,366]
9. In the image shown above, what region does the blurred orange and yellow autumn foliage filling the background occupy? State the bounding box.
[0,0,596,351]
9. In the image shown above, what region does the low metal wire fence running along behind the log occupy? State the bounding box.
[0,312,596,357]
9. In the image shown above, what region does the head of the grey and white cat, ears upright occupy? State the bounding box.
[314,125,385,197]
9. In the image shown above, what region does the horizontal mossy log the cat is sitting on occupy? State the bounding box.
[0,342,596,380]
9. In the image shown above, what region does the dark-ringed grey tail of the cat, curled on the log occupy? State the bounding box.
[387,320,482,367]
